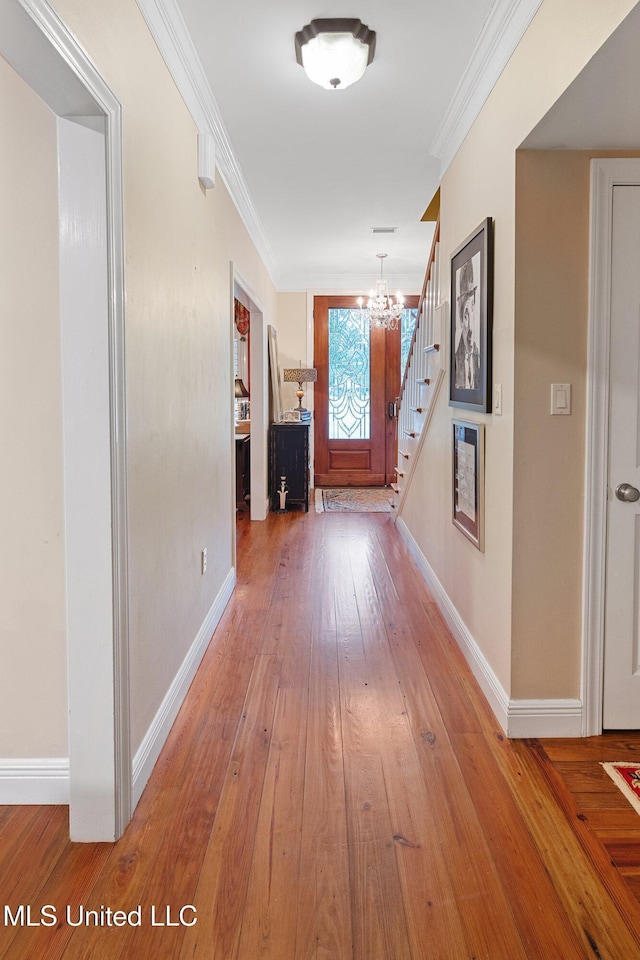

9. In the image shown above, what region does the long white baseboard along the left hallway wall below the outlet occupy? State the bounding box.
[133,568,236,809]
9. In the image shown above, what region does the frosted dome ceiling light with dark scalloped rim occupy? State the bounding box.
[295,17,376,90]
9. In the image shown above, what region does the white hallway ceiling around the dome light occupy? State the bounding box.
[177,0,500,293]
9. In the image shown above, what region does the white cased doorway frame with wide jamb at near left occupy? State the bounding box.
[0,0,132,841]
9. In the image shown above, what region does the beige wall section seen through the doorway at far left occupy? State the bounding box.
[0,57,67,758]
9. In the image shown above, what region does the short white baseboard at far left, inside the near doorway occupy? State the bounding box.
[0,757,69,806]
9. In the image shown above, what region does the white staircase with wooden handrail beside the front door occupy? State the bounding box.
[391,221,448,518]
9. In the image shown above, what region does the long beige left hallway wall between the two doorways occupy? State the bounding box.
[0,0,276,756]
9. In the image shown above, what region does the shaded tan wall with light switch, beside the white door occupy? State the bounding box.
[512,150,638,699]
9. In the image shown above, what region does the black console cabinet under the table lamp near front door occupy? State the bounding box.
[269,423,309,510]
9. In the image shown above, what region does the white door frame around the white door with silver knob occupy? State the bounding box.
[582,159,640,737]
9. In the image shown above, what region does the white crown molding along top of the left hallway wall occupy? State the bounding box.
[136,0,278,288]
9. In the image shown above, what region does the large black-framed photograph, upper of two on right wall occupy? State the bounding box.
[449,217,493,413]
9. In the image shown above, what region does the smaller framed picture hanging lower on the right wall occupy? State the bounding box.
[452,420,484,551]
